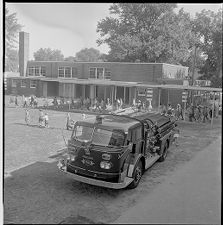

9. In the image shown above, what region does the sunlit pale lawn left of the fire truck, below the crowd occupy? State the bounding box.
[3,103,87,172]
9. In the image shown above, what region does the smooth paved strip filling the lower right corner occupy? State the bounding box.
[113,137,221,224]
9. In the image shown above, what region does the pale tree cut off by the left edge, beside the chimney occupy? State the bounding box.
[4,8,22,71]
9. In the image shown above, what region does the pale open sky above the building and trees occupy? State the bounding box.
[6,3,222,60]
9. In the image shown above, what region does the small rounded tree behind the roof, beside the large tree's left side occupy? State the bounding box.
[76,48,102,62]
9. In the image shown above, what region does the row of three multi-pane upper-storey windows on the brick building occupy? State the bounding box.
[28,66,111,79]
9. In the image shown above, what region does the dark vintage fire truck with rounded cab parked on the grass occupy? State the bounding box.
[57,112,177,189]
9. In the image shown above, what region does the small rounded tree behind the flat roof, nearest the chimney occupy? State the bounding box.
[33,48,64,61]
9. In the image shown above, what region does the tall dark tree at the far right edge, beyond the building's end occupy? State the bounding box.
[193,9,222,87]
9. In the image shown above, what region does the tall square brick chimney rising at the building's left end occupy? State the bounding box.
[19,31,29,77]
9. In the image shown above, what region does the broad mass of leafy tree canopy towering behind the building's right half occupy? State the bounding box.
[97,3,222,86]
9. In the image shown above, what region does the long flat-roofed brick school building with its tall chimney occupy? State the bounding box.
[5,32,188,107]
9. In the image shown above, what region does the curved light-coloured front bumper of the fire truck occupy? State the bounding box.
[57,161,133,189]
